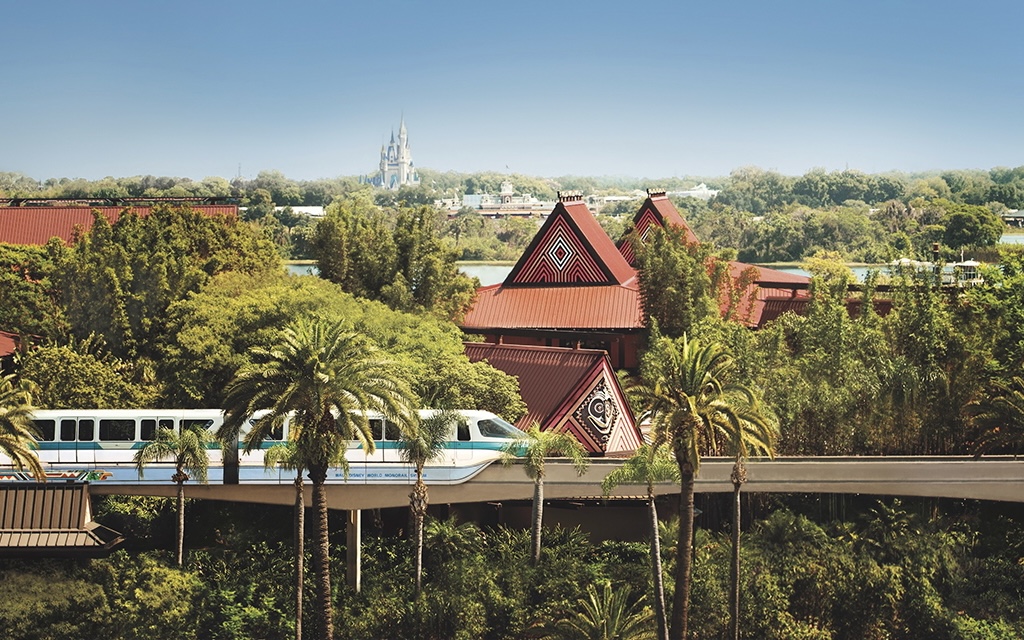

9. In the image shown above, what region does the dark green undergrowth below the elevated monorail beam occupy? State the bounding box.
[0,497,1024,640]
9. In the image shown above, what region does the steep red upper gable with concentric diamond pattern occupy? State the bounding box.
[504,197,636,287]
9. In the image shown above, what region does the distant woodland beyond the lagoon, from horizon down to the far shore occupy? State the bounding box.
[0,167,1024,263]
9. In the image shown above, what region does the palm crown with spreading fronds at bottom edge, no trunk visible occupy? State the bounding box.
[541,581,655,640]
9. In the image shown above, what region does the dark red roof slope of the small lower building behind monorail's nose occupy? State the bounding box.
[466,342,607,427]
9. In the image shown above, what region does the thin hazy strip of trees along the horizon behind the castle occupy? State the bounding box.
[6,166,1024,210]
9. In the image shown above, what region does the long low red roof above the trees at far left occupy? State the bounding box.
[0,205,239,245]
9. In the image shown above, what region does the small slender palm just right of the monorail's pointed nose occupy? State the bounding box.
[502,422,590,566]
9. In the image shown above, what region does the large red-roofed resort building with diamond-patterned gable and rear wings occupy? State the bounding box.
[462,190,810,368]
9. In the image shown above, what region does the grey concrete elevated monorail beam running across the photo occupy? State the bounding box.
[90,457,1024,510]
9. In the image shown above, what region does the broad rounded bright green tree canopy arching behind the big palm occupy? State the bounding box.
[159,273,525,413]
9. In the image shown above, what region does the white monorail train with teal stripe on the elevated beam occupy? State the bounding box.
[0,409,525,484]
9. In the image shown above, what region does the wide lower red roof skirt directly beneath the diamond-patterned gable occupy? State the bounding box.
[462,280,644,330]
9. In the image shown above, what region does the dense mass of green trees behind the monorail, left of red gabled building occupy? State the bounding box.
[0,205,524,419]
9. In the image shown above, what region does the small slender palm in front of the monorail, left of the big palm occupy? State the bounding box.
[132,424,214,566]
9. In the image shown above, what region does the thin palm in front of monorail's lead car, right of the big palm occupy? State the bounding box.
[398,411,454,597]
